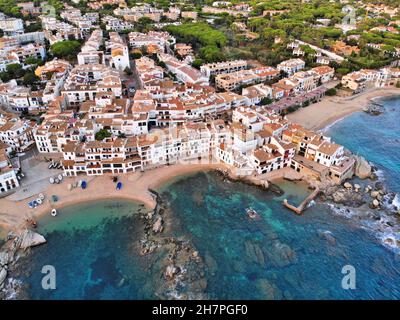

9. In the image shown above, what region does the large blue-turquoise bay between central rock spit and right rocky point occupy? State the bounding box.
[159,174,400,299]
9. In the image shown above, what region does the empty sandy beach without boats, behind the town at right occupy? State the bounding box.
[288,87,400,130]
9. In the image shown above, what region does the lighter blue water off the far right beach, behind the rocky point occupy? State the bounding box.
[327,97,400,192]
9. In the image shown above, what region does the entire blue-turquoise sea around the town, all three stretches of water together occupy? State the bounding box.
[3,98,400,300]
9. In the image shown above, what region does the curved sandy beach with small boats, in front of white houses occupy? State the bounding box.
[0,164,226,230]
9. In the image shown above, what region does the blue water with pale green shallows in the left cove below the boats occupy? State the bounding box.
[17,201,164,299]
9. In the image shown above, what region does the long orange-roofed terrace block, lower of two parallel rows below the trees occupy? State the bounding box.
[215,67,279,91]
